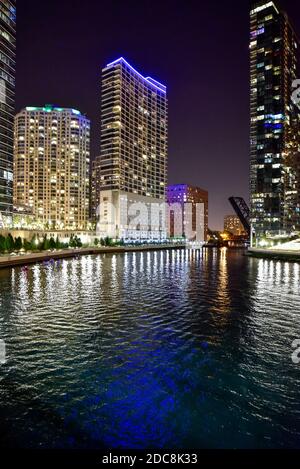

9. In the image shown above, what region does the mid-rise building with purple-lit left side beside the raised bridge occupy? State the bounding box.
[167,184,208,241]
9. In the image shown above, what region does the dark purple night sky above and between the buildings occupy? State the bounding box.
[17,0,300,229]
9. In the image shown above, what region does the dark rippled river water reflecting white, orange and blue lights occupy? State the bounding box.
[0,250,300,449]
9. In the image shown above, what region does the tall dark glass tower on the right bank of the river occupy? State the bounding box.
[250,1,300,238]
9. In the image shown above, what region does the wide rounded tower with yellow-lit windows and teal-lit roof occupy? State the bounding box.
[14,105,90,230]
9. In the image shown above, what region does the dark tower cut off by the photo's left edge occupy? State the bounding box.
[0,0,16,224]
